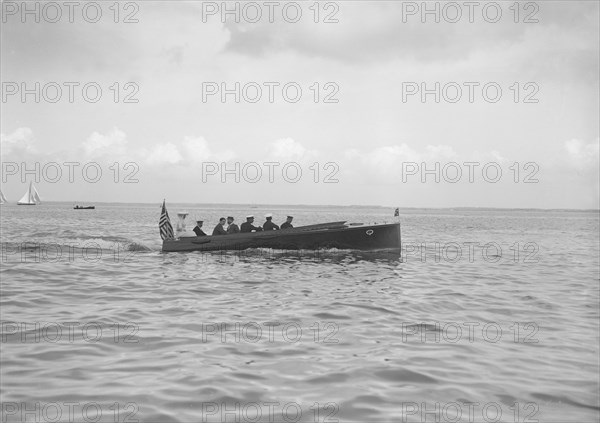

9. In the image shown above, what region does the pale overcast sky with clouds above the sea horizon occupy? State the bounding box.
[0,1,600,209]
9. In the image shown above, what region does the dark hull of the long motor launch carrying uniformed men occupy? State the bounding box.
[163,223,400,252]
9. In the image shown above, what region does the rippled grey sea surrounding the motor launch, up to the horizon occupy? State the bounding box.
[0,202,600,423]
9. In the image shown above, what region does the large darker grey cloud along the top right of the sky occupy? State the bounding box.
[225,2,598,63]
